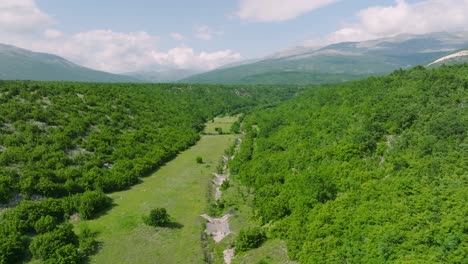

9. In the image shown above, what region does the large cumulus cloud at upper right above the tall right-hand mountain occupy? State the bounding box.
[327,0,468,43]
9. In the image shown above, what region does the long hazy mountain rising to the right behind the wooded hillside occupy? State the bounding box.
[182,32,468,84]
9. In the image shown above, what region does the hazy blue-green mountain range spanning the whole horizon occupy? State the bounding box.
[0,32,468,84]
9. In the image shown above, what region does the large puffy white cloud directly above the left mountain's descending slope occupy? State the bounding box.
[27,30,158,72]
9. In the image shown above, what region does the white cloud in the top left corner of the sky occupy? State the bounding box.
[0,0,52,33]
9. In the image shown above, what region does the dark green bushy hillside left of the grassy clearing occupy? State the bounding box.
[0,81,296,263]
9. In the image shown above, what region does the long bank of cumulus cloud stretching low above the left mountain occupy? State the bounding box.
[0,29,241,73]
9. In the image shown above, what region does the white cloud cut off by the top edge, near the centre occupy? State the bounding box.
[236,0,337,22]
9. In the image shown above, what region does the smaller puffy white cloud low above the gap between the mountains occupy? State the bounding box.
[152,47,241,70]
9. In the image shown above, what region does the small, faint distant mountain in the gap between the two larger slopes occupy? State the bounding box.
[124,69,200,83]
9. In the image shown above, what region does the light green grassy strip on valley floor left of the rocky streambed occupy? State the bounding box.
[76,134,235,263]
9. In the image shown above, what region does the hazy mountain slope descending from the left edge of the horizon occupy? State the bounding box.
[0,44,141,82]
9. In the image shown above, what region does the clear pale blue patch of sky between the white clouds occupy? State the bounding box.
[37,0,402,57]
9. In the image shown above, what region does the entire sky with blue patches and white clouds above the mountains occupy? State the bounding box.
[0,0,468,73]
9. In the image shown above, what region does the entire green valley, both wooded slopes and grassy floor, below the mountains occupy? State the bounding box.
[0,65,468,263]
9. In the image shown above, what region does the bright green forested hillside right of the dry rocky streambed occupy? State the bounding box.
[231,66,468,263]
